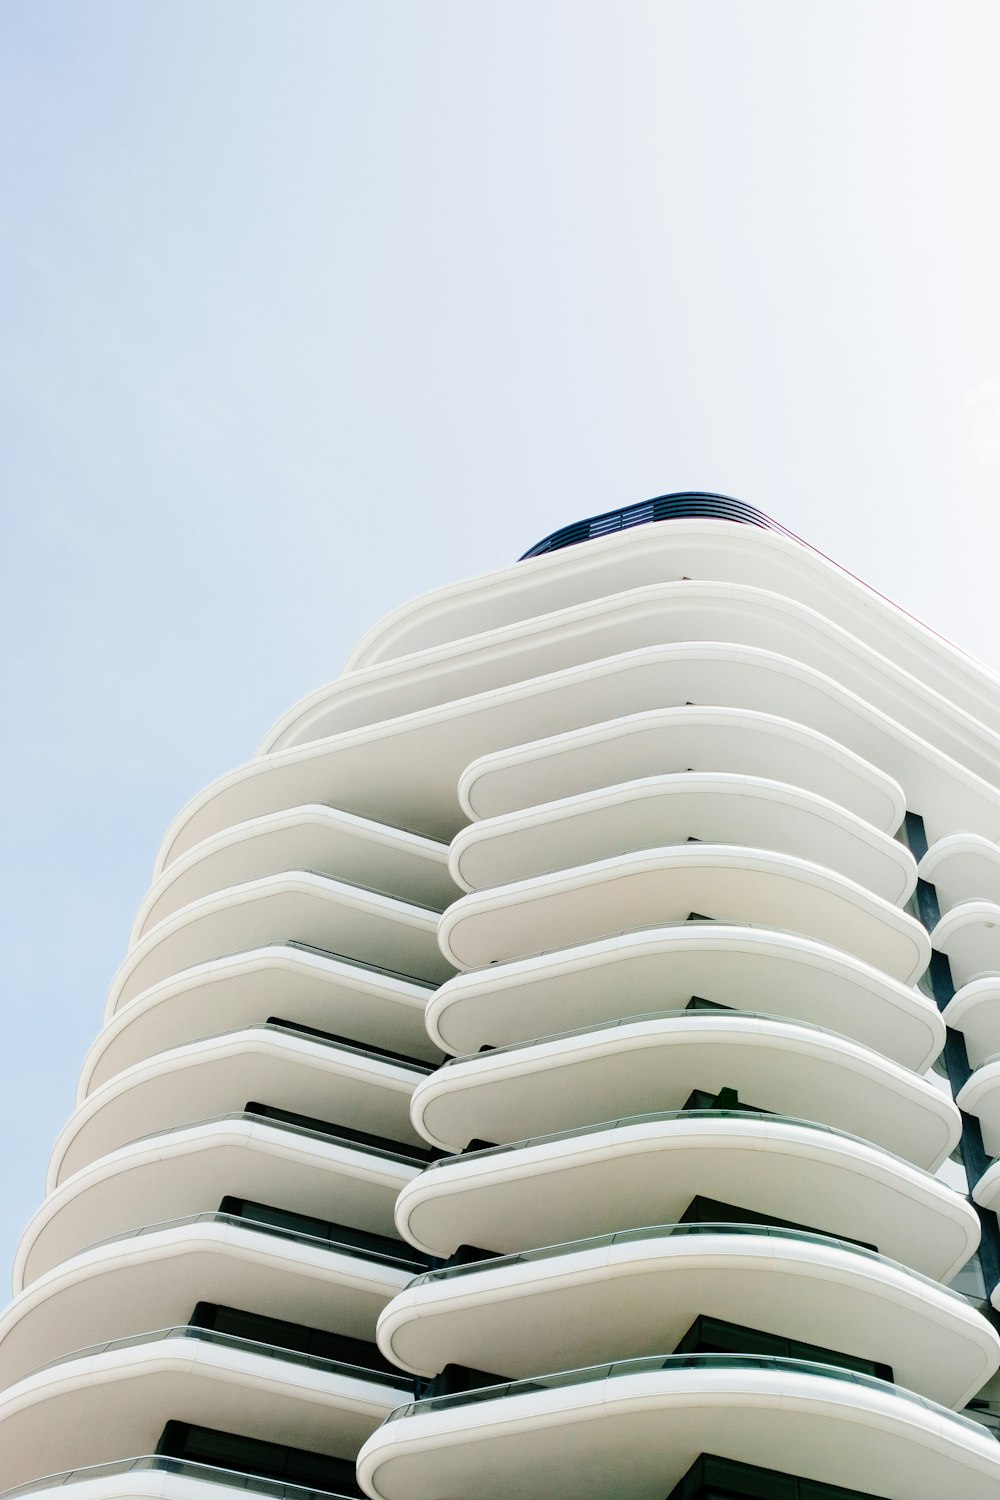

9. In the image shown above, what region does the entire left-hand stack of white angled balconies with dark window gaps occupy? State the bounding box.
[0,803,456,1497]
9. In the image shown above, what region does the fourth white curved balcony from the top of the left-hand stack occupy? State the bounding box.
[52,1023,427,1193]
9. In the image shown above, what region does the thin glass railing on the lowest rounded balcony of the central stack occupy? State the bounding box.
[384,1355,984,1433]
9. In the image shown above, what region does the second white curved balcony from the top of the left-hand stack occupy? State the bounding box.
[105,870,451,1020]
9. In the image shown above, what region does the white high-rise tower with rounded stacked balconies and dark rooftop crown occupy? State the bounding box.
[0,494,1000,1500]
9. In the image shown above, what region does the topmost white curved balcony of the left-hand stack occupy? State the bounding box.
[129,804,457,948]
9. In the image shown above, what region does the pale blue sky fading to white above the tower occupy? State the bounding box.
[0,0,1000,1290]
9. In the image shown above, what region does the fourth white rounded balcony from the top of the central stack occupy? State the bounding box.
[426,921,941,1073]
